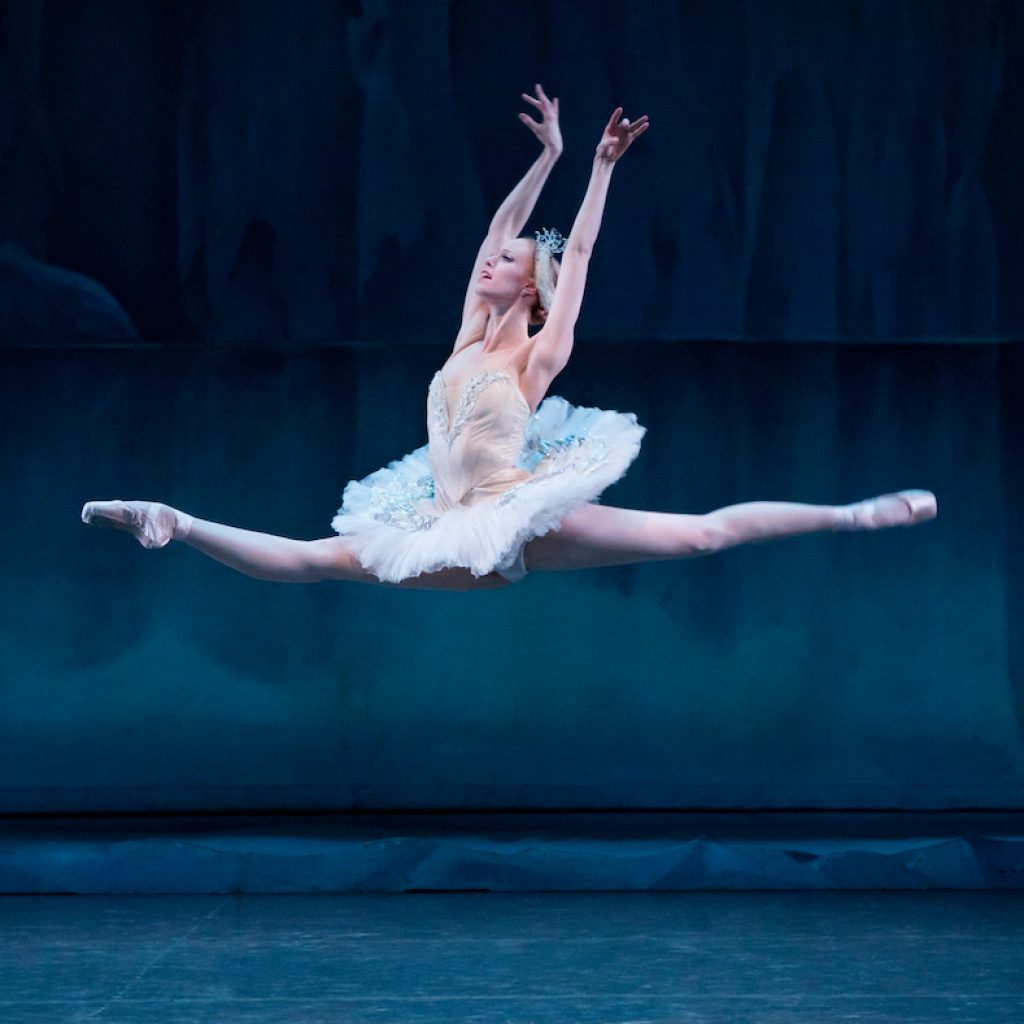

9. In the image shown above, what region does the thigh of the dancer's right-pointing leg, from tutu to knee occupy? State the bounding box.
[525,505,715,571]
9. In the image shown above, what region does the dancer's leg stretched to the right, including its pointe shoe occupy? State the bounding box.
[525,490,936,571]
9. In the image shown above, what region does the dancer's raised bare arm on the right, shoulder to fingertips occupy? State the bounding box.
[523,106,649,395]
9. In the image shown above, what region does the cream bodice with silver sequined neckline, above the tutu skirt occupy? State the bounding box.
[427,370,530,510]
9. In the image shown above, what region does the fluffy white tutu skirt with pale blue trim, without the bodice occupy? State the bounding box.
[331,397,646,583]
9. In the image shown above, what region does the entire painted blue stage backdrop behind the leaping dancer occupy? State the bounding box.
[0,0,1024,811]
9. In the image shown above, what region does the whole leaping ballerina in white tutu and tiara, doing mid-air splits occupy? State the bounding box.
[82,85,937,590]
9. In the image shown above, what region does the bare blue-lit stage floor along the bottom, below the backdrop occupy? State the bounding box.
[0,892,1024,1024]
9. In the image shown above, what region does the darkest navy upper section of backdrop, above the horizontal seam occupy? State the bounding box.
[0,0,1024,344]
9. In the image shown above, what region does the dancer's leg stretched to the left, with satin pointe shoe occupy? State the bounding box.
[82,501,508,590]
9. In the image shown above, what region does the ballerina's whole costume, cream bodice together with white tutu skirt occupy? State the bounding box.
[331,372,645,583]
